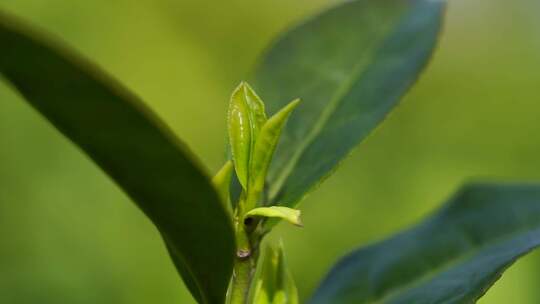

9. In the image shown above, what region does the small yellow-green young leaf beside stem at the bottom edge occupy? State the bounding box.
[251,244,298,304]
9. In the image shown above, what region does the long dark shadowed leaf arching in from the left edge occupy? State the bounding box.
[0,14,234,304]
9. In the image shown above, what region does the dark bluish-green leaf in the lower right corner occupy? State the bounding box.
[310,185,540,304]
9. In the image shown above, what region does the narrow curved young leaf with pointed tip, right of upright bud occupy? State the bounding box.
[249,99,300,207]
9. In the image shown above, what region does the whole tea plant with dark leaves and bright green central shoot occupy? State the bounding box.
[0,0,540,304]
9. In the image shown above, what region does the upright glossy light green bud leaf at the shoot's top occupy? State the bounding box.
[228,82,266,189]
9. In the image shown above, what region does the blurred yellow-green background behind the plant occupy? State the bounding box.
[0,0,540,304]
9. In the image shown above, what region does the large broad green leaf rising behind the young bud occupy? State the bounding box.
[252,0,444,206]
